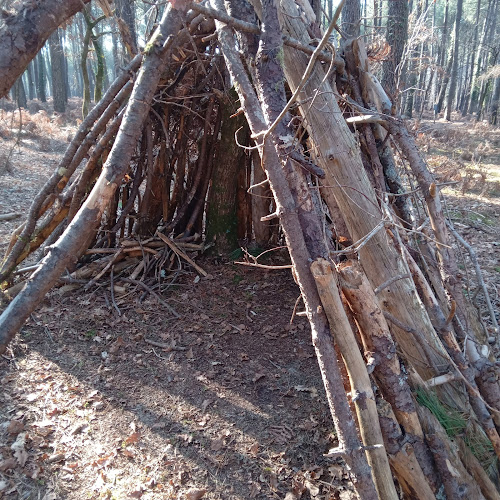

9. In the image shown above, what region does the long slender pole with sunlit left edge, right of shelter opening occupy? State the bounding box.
[211,0,378,500]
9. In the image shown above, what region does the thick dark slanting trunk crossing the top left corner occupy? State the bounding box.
[0,0,90,97]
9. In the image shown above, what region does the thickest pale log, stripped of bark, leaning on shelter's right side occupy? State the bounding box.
[282,1,446,390]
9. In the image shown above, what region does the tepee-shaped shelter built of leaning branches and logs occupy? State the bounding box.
[0,0,500,500]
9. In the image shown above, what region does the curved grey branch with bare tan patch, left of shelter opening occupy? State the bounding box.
[0,7,186,353]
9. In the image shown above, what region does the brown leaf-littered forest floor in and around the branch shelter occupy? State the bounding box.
[0,104,500,500]
